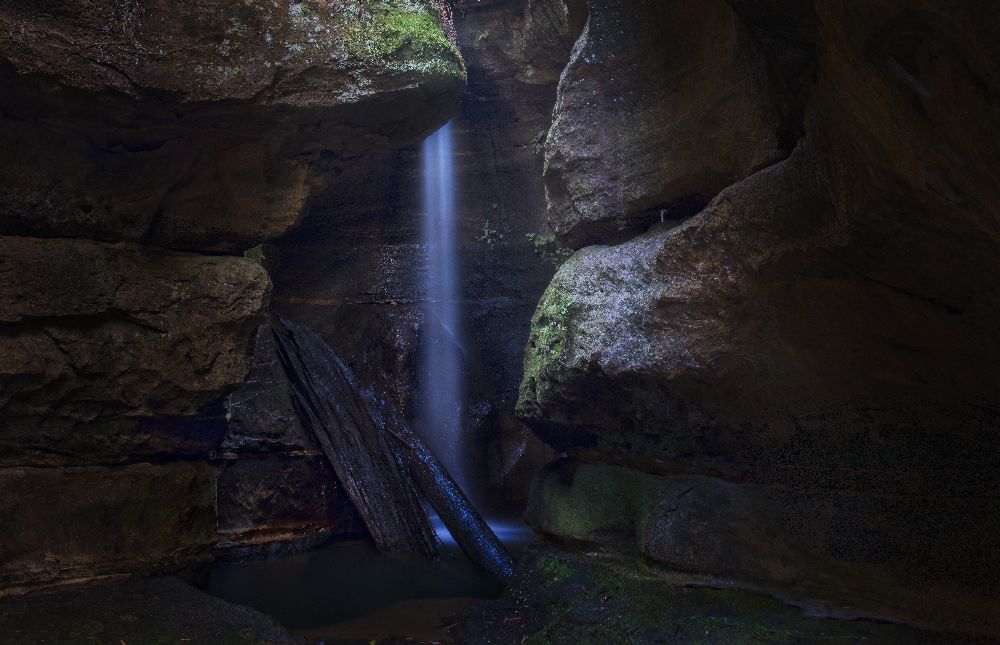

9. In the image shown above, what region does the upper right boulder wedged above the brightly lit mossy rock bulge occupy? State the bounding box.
[545,0,794,247]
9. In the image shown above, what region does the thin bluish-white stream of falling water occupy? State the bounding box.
[420,123,469,490]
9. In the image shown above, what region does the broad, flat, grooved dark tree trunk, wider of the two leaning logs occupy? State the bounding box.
[272,319,438,559]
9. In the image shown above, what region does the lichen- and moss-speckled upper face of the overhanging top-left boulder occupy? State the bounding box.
[0,0,464,106]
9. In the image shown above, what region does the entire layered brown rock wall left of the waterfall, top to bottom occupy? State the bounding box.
[0,0,465,593]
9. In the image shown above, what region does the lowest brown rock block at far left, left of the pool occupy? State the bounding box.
[0,462,215,592]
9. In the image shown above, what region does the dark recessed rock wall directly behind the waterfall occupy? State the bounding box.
[265,0,571,508]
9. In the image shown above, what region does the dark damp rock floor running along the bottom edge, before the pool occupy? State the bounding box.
[0,545,997,645]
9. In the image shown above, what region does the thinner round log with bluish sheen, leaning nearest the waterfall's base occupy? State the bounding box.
[383,407,514,578]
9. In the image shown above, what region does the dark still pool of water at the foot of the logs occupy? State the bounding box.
[205,521,531,632]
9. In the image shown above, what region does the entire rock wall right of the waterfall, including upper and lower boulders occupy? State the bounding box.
[518,0,1000,634]
